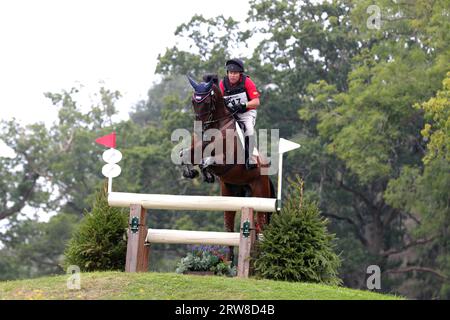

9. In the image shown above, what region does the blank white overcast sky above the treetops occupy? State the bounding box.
[0,0,249,155]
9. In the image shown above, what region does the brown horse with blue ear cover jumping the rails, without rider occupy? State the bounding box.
[180,76,275,261]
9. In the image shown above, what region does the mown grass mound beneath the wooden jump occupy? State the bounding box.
[0,272,403,300]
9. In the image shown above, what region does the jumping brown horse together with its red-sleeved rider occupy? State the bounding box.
[186,70,275,248]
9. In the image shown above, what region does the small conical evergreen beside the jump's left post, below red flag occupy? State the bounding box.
[64,187,128,272]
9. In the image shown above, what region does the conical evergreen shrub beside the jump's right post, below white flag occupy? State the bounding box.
[254,177,342,285]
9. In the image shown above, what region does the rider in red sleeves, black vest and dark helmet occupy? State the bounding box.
[219,59,260,170]
